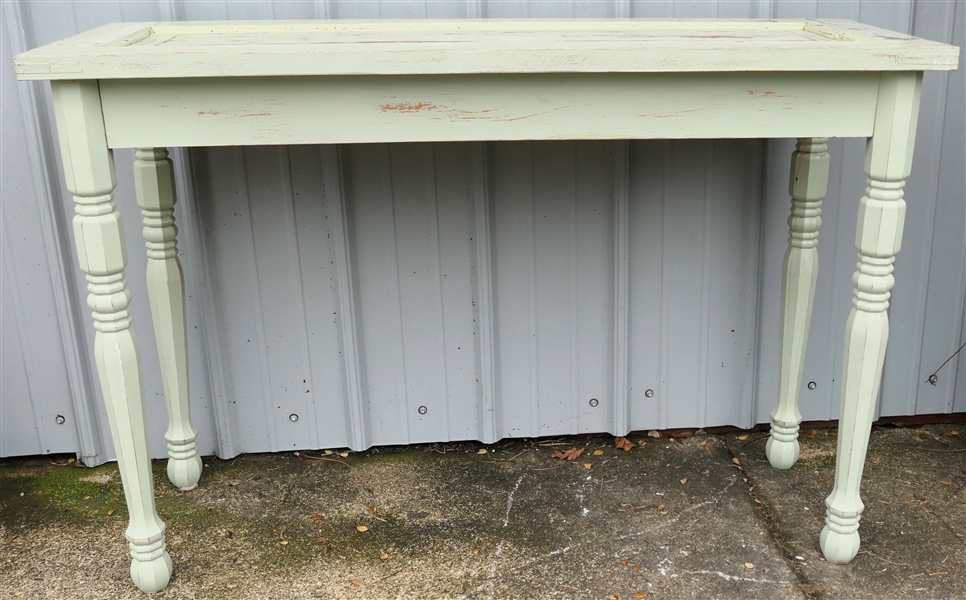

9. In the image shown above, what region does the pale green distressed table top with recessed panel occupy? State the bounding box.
[14,19,959,79]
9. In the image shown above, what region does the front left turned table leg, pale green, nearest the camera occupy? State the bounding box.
[51,81,171,592]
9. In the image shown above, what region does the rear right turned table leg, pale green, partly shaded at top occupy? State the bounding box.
[765,138,829,469]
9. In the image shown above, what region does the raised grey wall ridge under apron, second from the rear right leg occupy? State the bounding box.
[611,140,631,435]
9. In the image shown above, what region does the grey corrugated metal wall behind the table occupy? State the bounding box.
[0,0,966,464]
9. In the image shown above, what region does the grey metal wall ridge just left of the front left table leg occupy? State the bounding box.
[3,0,105,466]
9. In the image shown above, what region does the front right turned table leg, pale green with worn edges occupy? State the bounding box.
[820,73,922,564]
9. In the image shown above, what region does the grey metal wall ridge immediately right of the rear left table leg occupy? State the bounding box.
[172,148,239,459]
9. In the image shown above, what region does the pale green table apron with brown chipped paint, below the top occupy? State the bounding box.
[99,72,880,148]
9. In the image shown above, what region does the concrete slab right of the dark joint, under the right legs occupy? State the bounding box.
[736,425,966,599]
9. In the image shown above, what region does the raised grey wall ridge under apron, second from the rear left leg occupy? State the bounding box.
[321,146,372,451]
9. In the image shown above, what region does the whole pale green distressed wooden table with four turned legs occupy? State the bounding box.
[15,20,959,592]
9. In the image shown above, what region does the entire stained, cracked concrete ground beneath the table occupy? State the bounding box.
[0,425,966,600]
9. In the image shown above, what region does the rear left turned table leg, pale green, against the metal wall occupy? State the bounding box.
[134,148,201,491]
